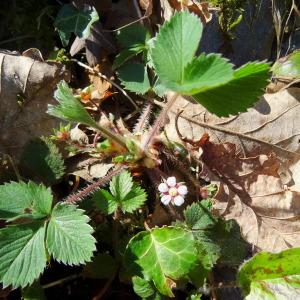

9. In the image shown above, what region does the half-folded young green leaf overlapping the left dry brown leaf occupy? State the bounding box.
[47,80,97,128]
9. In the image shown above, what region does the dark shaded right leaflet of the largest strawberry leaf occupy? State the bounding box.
[193,62,270,117]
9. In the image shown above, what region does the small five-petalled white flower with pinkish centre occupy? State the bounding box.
[158,176,188,206]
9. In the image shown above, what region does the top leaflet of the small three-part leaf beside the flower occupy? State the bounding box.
[109,171,133,201]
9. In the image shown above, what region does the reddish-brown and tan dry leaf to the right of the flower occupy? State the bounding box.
[201,137,300,252]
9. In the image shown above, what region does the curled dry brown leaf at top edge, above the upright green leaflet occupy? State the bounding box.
[168,0,212,24]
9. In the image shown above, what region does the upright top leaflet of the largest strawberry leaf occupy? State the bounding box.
[151,11,202,88]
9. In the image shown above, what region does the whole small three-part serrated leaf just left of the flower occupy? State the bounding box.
[93,171,147,215]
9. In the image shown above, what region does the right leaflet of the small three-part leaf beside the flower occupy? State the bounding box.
[120,184,147,213]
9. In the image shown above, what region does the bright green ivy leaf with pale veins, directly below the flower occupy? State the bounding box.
[124,227,198,297]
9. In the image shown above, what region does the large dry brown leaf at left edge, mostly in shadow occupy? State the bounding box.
[0,51,69,159]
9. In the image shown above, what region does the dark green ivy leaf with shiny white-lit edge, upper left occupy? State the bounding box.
[54,4,99,47]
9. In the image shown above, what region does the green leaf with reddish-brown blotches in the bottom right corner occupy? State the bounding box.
[237,248,300,299]
